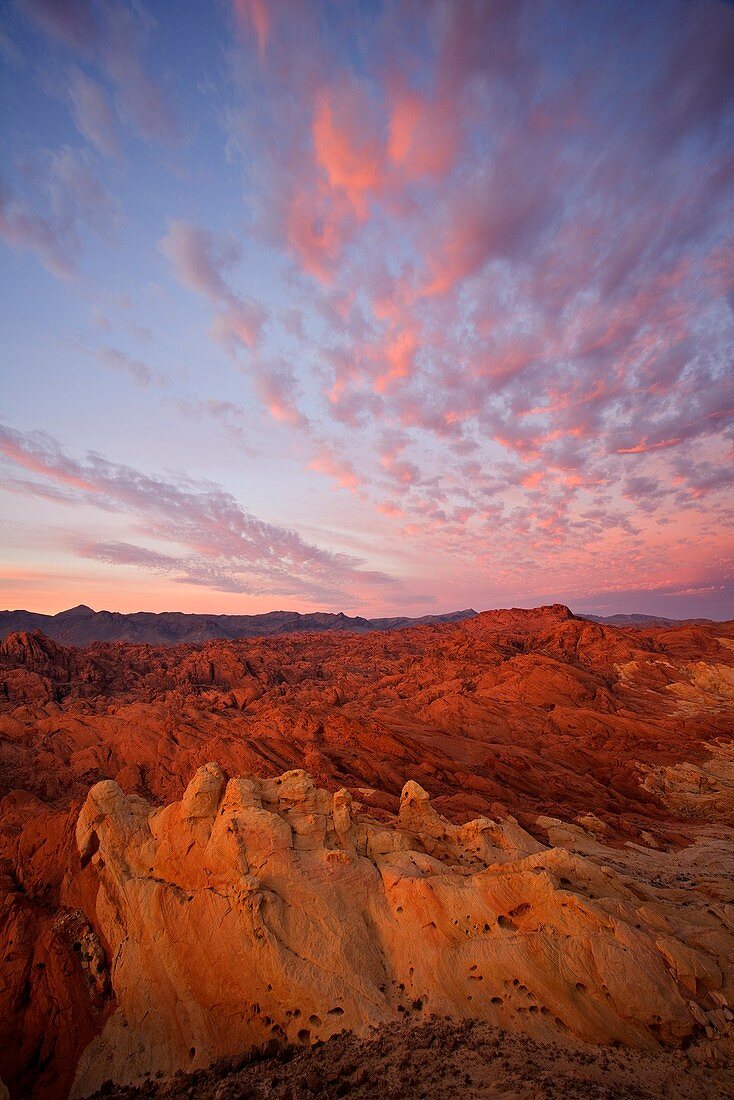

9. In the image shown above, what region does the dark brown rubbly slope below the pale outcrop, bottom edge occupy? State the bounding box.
[80,1019,734,1100]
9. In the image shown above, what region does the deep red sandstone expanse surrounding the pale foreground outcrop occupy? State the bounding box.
[0,607,734,1098]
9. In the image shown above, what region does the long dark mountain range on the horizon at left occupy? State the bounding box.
[0,604,476,646]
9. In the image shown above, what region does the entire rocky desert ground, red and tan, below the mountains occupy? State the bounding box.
[0,605,734,1100]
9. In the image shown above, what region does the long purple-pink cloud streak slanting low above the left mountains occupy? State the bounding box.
[0,427,395,603]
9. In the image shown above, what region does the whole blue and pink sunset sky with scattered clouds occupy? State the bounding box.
[0,0,734,618]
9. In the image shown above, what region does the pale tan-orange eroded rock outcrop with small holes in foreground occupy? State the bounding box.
[73,763,734,1097]
